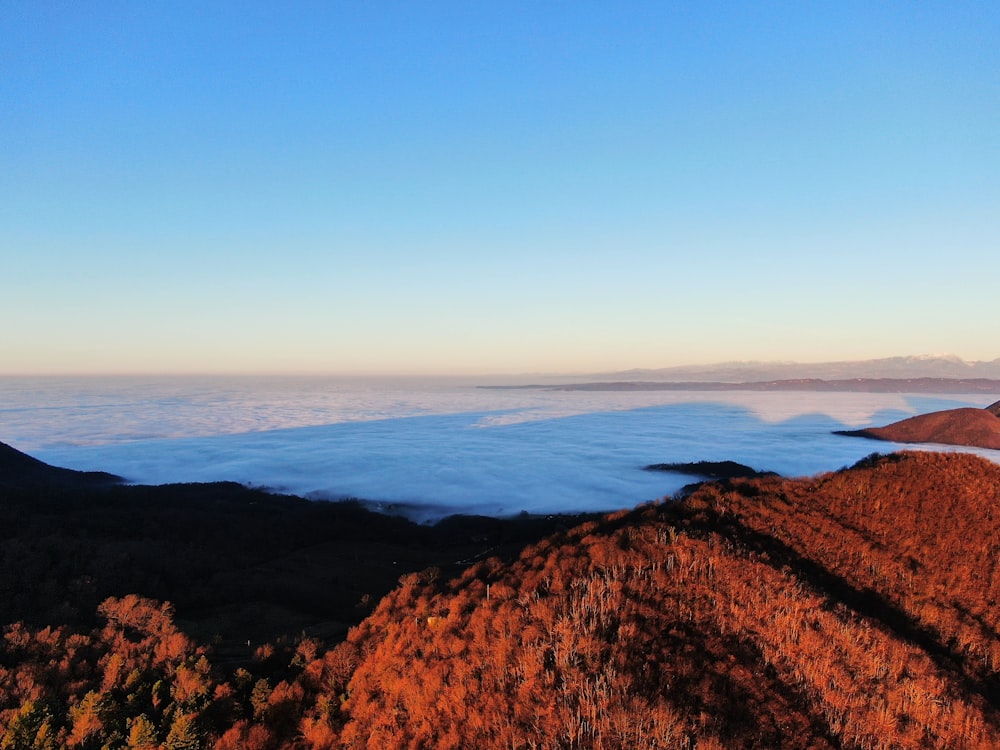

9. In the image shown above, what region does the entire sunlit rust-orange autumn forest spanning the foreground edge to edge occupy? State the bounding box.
[0,453,1000,750]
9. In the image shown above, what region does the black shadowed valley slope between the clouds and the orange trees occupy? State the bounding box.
[0,444,596,644]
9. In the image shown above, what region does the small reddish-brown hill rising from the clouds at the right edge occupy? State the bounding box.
[838,402,1000,450]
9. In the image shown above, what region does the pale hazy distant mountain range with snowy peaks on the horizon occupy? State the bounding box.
[596,355,1000,383]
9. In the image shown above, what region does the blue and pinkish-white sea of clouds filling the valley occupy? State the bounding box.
[0,378,1000,520]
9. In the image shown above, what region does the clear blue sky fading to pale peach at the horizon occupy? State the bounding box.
[0,0,1000,374]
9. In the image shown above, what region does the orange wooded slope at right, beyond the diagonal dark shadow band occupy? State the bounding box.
[685,452,1000,704]
